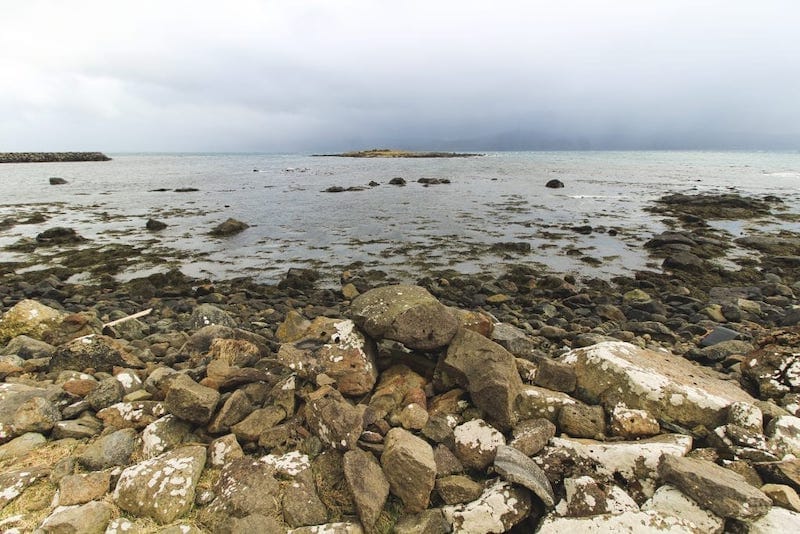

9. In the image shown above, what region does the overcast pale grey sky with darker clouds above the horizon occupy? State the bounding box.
[0,0,800,153]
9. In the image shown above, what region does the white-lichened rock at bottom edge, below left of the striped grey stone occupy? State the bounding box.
[442,480,531,533]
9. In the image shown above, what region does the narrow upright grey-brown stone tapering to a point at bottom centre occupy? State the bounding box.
[344,449,389,532]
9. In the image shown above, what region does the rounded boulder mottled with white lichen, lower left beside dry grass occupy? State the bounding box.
[114,445,206,524]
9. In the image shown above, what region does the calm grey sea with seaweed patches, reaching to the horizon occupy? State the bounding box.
[0,152,800,281]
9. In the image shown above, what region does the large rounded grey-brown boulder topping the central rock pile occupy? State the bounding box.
[351,285,458,350]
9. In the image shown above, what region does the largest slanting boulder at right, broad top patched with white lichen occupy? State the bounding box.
[562,342,755,428]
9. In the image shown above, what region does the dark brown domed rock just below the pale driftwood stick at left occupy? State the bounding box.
[48,335,144,373]
